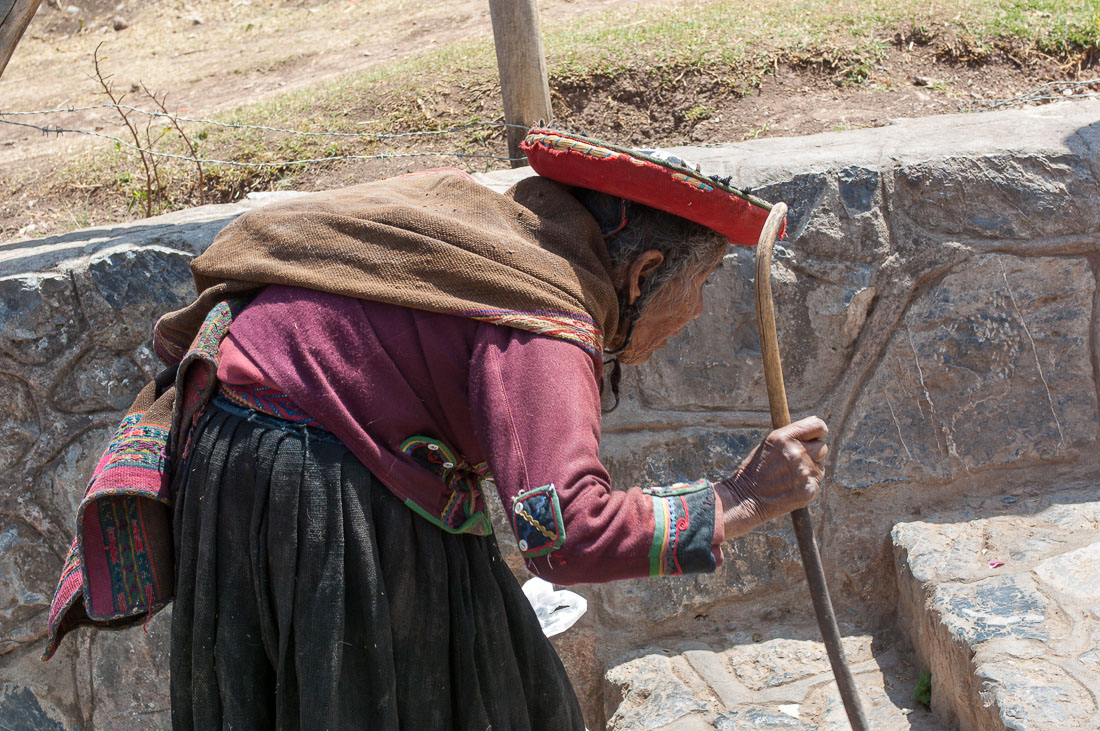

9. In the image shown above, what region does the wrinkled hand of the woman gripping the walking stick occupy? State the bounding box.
[715,417,828,539]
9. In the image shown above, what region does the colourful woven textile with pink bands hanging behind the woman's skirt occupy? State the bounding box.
[43,300,244,660]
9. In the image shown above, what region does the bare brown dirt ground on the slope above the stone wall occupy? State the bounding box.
[0,0,1100,241]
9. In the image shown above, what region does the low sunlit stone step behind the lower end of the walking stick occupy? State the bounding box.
[605,625,946,731]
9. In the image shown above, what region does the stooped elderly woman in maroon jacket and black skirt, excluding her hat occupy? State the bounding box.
[49,132,826,731]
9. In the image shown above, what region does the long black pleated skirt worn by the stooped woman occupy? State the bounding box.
[172,401,584,731]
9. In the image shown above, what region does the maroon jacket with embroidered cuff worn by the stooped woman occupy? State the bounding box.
[218,286,723,584]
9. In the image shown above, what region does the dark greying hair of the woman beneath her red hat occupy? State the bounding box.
[573,188,729,312]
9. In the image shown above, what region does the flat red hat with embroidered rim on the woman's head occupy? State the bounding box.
[519,128,787,246]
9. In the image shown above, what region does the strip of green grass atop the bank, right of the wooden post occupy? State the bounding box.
[545,0,1100,77]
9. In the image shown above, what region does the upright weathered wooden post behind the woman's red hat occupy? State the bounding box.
[488,0,552,167]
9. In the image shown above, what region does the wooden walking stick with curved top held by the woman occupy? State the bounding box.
[756,203,868,731]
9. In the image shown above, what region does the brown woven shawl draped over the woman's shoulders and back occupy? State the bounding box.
[156,170,618,362]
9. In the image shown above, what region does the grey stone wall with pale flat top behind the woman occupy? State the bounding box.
[0,102,1100,729]
